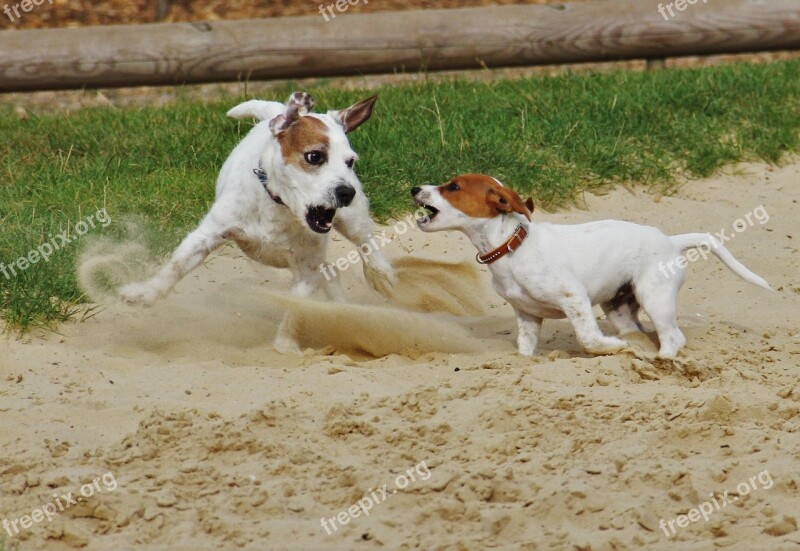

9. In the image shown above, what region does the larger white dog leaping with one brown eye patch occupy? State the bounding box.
[120,92,396,348]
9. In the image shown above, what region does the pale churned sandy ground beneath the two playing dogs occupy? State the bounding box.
[0,164,800,550]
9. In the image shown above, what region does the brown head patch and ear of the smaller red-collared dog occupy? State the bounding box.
[439,174,531,220]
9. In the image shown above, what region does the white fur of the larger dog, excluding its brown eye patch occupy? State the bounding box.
[120,94,396,349]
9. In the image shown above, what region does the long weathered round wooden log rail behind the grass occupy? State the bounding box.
[0,0,800,92]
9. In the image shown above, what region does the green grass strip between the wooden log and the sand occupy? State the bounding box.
[0,61,800,329]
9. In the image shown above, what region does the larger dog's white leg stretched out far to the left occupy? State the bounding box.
[119,215,226,306]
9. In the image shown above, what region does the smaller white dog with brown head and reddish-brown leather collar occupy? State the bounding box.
[411,174,770,358]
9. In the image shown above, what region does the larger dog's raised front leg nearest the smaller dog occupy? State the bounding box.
[333,193,397,296]
